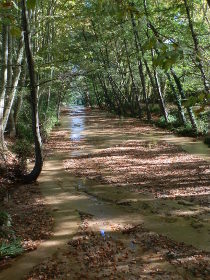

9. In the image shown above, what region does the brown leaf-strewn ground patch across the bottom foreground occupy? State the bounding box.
[26,214,210,280]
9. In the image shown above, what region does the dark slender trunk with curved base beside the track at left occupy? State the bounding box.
[22,0,43,182]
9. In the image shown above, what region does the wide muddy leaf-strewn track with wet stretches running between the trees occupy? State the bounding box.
[0,108,210,279]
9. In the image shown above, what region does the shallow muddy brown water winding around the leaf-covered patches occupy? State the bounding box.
[0,106,210,280]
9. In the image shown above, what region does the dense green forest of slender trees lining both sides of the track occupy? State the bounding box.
[0,0,210,279]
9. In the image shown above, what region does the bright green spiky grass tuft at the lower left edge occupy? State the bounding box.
[0,239,24,259]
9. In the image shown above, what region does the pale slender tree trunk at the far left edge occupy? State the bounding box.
[0,24,8,159]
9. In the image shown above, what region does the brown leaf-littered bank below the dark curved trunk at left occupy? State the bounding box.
[0,184,53,269]
